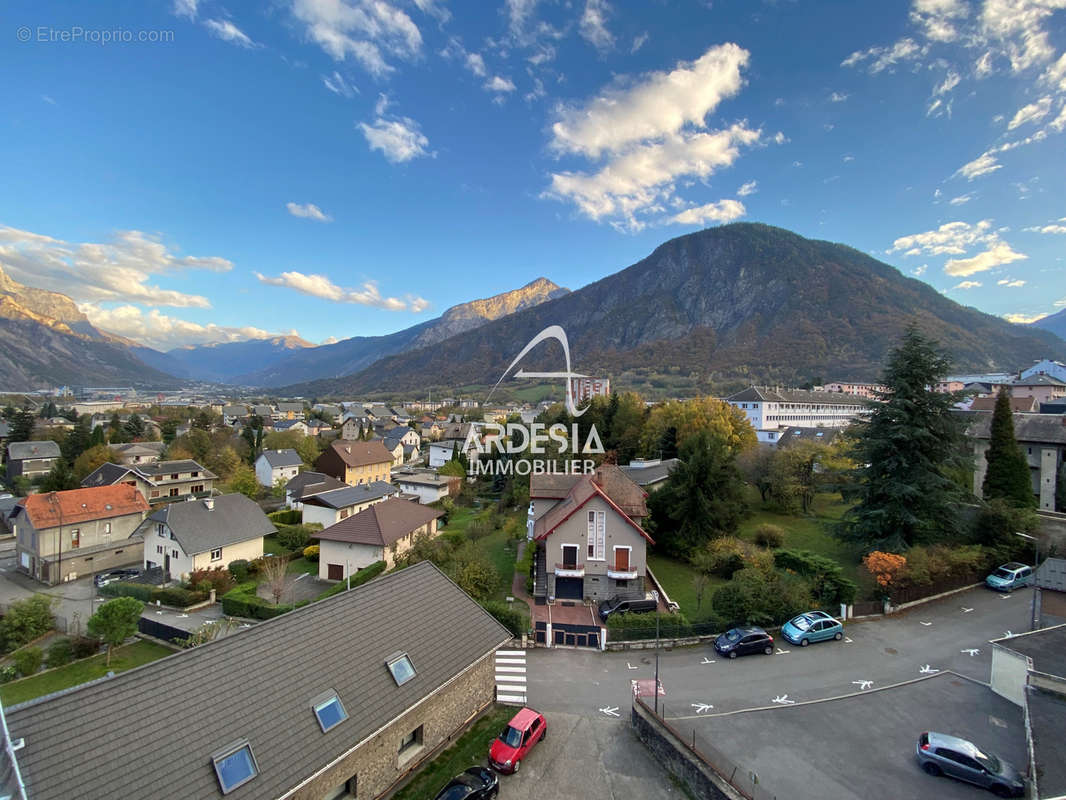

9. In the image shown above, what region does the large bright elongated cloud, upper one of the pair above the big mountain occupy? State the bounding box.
[551,44,749,158]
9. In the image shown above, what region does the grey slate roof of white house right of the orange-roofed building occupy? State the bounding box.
[141,494,277,556]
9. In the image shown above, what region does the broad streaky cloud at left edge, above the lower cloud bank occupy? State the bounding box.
[0,226,233,308]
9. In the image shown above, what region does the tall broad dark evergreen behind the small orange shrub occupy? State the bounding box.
[837,325,963,553]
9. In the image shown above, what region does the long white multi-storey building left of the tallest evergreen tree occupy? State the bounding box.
[725,386,868,445]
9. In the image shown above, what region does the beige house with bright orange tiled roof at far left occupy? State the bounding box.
[9,483,148,586]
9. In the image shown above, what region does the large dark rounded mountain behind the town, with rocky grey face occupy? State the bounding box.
[281,223,1066,397]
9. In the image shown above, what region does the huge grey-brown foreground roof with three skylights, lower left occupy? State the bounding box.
[5,561,511,800]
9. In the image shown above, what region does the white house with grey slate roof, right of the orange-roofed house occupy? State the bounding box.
[138,494,277,580]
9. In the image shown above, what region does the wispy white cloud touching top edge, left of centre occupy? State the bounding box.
[292,0,422,77]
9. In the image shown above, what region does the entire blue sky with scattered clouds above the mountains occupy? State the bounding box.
[0,0,1066,348]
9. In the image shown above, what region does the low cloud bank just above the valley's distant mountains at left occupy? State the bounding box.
[78,303,300,350]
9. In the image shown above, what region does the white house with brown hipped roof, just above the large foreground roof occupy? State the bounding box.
[304,497,443,580]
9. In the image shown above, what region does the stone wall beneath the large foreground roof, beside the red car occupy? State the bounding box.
[286,653,496,800]
